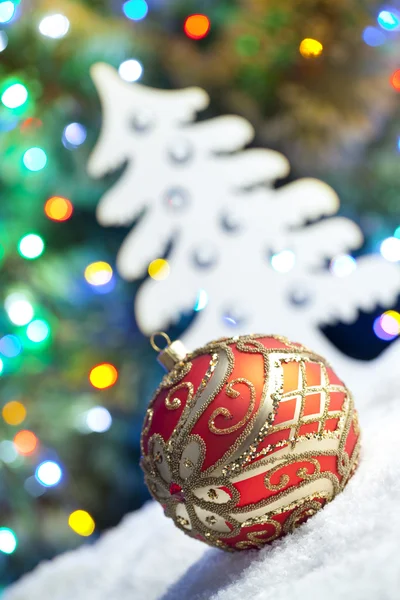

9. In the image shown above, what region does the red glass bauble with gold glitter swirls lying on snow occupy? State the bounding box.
[141,335,359,550]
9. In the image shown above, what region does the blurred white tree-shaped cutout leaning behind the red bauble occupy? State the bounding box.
[89,64,400,404]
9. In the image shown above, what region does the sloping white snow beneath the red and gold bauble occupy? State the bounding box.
[4,390,400,600]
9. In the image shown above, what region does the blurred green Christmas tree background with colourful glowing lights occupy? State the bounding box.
[0,0,400,584]
